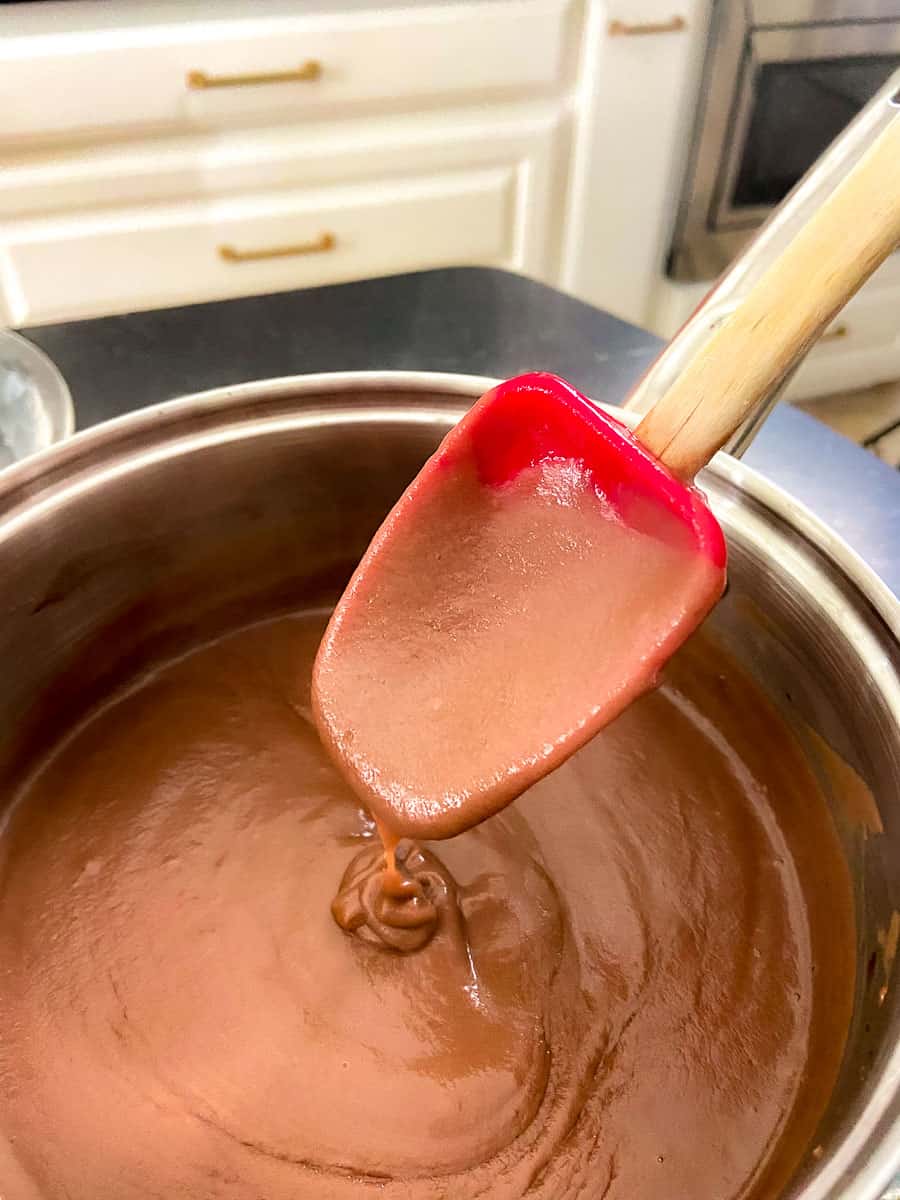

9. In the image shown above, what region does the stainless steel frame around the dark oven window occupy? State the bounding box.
[668,0,900,282]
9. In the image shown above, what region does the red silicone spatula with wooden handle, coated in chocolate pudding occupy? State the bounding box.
[313,112,900,838]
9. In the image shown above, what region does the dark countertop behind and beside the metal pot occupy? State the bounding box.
[22,268,900,596]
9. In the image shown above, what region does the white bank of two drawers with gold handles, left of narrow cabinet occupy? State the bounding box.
[0,0,573,324]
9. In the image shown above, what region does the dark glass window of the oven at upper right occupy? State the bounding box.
[732,54,900,209]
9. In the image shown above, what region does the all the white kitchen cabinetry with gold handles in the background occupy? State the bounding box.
[0,0,900,412]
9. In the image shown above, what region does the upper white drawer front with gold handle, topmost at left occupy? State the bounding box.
[0,0,574,144]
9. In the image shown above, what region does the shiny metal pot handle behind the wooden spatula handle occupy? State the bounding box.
[625,68,900,457]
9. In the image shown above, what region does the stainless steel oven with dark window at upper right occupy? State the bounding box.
[667,0,900,281]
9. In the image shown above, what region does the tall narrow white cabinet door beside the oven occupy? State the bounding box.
[562,0,707,324]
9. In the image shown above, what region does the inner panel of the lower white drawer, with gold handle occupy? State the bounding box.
[4,167,518,324]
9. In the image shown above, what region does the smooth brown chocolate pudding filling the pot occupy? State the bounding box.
[0,614,853,1200]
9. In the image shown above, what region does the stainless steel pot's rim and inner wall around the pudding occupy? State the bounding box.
[0,372,900,1200]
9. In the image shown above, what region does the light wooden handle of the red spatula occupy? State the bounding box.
[637,112,900,480]
